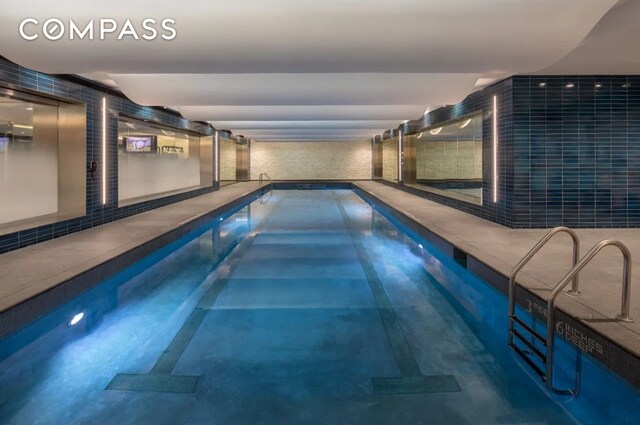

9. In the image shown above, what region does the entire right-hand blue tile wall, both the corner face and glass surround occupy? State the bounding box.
[400,76,640,228]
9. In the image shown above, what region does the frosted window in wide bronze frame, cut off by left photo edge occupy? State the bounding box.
[0,92,86,234]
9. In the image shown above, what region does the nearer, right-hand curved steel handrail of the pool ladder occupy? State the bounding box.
[546,239,633,390]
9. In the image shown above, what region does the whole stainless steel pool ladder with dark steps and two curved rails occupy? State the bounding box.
[508,227,633,396]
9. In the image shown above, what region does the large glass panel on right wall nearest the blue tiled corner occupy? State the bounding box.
[415,114,482,205]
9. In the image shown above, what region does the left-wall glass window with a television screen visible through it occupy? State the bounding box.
[118,116,210,206]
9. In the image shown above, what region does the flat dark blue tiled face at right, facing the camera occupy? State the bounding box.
[512,76,640,228]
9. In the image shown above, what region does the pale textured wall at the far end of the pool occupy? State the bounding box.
[249,140,371,180]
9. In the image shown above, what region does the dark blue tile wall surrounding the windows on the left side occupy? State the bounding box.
[0,57,217,253]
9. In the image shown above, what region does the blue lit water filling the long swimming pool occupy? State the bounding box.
[0,190,640,425]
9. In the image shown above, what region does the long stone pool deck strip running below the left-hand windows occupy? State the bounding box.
[0,182,264,330]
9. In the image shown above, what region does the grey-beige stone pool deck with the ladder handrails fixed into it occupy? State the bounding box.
[353,181,640,356]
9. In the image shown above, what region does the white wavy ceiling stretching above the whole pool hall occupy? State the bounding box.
[0,0,640,140]
